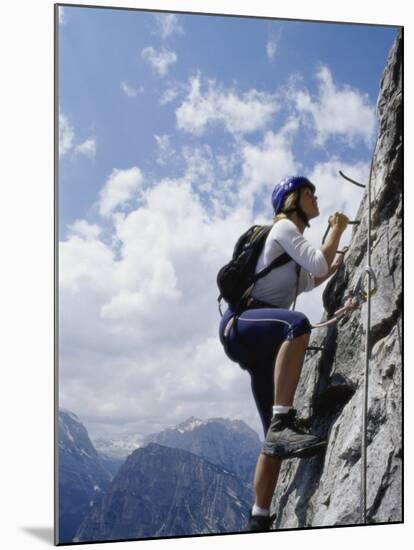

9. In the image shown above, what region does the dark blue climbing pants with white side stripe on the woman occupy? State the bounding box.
[219,308,312,434]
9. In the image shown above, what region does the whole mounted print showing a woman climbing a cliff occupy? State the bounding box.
[55,4,403,545]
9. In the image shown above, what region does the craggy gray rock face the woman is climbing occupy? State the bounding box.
[272,30,402,529]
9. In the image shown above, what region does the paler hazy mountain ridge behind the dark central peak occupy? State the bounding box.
[144,416,261,483]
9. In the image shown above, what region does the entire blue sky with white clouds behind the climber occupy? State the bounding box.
[59,6,398,437]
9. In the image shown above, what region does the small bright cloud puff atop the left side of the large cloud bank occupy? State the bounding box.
[98,166,143,217]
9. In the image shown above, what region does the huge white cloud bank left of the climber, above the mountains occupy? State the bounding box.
[60,151,259,435]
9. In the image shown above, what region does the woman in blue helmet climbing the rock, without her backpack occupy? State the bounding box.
[219,176,349,531]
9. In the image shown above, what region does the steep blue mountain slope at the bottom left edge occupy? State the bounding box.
[58,410,113,543]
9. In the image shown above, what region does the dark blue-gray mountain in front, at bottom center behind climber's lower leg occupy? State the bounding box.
[74,443,252,542]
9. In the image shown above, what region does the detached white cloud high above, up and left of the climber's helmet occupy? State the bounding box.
[176,75,278,135]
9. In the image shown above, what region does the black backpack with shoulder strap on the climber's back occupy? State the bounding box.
[217,225,293,313]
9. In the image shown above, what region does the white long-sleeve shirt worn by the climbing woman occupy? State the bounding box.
[251,219,329,309]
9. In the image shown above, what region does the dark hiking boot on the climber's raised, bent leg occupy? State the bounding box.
[262,409,326,458]
